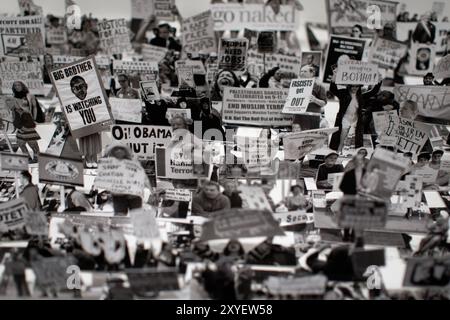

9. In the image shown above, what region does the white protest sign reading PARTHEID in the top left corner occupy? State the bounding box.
[0,15,45,57]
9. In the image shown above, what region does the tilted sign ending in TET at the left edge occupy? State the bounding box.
[0,198,28,231]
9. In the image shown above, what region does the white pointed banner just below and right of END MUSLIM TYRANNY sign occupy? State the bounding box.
[283,128,339,160]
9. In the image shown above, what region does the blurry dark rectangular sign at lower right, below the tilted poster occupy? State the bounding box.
[337,196,388,230]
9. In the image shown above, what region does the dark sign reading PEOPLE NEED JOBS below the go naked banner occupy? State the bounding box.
[218,38,248,72]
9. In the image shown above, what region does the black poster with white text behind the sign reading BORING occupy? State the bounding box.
[323,35,366,83]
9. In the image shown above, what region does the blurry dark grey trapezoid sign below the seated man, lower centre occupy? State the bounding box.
[200,209,284,241]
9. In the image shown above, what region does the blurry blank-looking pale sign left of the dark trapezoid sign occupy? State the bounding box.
[130,208,160,240]
